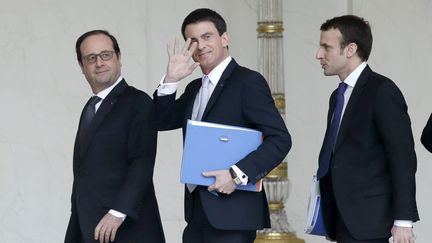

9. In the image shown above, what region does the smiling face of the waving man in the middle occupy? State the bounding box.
[185,21,228,74]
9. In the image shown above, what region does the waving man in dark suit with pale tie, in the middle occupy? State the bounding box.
[154,9,291,243]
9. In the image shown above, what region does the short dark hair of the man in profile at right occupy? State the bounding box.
[320,15,373,61]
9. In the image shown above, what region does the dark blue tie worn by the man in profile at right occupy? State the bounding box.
[317,82,347,180]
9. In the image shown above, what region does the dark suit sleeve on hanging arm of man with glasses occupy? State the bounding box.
[113,95,157,220]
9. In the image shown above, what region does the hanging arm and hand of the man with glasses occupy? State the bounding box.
[95,95,157,243]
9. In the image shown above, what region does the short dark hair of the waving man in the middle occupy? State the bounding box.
[181,8,226,40]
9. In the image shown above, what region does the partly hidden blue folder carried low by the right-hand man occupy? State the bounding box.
[304,176,327,236]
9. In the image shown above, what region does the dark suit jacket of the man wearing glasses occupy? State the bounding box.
[65,80,165,243]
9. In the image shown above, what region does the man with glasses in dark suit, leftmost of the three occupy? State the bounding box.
[65,30,165,243]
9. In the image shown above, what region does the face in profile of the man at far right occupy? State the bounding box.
[316,29,350,80]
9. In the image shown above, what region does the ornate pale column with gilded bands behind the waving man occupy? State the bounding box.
[255,0,306,243]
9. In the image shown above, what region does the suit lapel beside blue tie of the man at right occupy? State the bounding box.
[334,66,372,152]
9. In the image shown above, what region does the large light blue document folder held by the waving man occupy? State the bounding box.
[180,120,262,192]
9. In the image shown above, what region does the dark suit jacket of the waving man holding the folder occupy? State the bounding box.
[154,60,291,230]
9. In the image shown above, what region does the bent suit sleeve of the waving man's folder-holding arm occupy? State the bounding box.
[236,72,291,183]
